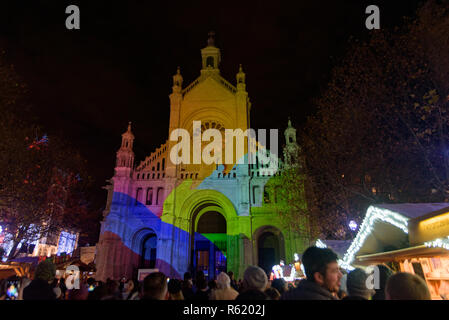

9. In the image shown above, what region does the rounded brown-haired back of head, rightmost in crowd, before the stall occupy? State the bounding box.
[385,272,430,300]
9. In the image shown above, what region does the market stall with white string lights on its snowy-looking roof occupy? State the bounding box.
[343,203,449,299]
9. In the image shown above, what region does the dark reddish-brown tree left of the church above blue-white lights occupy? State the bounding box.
[0,49,90,259]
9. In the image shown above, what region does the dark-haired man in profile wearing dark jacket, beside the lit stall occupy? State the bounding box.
[281,246,343,300]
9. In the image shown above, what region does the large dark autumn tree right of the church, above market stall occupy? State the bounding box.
[302,1,449,238]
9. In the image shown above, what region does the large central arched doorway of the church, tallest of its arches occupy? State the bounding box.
[191,207,227,280]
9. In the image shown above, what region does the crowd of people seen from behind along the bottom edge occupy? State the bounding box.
[0,247,430,301]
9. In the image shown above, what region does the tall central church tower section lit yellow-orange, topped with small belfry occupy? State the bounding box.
[166,32,251,178]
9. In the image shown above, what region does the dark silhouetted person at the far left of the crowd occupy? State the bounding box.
[23,260,56,300]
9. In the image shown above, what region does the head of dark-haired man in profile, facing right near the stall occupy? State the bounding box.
[302,246,343,292]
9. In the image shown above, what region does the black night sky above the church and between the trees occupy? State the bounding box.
[0,0,419,206]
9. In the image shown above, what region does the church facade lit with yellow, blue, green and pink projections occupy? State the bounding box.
[96,33,309,280]
